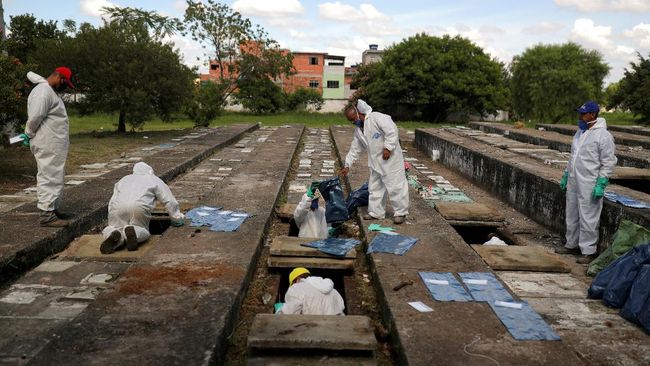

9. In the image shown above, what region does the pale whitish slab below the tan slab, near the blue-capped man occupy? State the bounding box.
[497,272,589,299]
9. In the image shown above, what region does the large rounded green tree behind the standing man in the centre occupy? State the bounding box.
[355,34,507,121]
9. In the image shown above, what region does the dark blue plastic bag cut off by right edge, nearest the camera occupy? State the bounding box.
[620,264,650,334]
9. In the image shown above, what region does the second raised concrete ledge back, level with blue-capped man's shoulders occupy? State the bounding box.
[469,122,650,169]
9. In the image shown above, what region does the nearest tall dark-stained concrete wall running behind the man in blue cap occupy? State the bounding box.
[415,129,650,250]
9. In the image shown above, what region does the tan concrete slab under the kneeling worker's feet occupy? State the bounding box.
[59,234,160,262]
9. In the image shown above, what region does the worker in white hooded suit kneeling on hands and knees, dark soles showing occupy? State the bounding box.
[99,162,185,254]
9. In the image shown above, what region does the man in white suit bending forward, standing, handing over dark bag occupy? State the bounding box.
[341,99,409,224]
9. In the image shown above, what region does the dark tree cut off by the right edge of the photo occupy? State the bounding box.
[609,54,650,124]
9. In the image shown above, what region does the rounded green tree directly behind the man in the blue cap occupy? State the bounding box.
[510,43,609,123]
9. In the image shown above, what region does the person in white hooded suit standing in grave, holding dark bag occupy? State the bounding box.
[293,182,328,239]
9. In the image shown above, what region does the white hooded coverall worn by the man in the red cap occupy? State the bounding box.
[25,71,70,211]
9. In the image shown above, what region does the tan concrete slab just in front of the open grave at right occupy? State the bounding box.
[472,245,571,273]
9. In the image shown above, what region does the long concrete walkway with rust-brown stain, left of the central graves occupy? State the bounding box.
[30,126,303,365]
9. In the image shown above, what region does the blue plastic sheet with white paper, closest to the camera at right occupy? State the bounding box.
[489,301,560,341]
